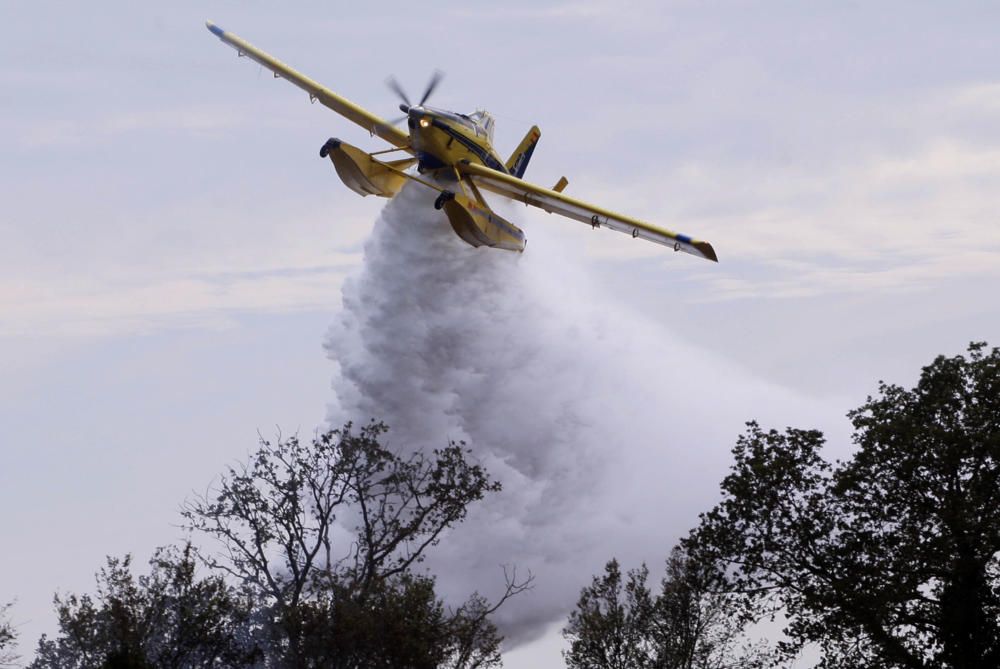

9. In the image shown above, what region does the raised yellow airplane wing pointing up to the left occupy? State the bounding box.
[205,21,412,153]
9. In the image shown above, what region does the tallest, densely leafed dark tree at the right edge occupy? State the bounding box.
[686,344,1000,669]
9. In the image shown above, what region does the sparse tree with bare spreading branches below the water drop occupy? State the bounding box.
[183,423,530,667]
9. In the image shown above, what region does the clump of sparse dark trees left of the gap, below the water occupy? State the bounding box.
[34,423,531,669]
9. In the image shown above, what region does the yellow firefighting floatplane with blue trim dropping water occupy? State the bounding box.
[205,21,718,262]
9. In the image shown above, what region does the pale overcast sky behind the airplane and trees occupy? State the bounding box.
[0,0,1000,668]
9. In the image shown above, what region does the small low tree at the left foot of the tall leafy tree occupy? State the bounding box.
[563,547,773,669]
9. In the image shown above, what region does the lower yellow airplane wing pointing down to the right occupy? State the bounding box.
[456,161,719,262]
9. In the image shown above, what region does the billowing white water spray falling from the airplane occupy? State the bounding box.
[326,180,828,644]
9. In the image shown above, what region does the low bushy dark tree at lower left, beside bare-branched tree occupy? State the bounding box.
[29,545,260,669]
